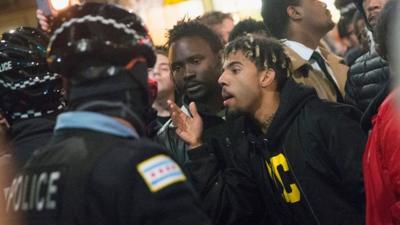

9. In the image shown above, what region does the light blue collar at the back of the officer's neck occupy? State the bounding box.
[55,111,139,138]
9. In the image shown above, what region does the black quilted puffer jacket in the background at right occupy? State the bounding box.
[345,51,389,112]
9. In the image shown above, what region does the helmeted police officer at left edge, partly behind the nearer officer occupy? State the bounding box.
[0,27,65,169]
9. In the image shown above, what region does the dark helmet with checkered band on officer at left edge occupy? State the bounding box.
[0,27,65,123]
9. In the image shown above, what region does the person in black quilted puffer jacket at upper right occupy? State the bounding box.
[345,0,390,121]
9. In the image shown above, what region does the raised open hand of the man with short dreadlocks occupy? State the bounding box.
[168,100,203,149]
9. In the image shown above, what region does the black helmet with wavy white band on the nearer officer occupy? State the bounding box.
[48,2,156,76]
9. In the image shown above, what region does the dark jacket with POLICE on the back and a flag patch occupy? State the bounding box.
[2,128,209,225]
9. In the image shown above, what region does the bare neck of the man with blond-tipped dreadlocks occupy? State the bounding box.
[253,92,280,134]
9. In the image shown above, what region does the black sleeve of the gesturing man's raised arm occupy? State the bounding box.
[185,144,272,225]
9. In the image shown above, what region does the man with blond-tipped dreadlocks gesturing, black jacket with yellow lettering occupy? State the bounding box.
[170,35,365,225]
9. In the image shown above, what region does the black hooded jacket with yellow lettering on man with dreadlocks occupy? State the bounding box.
[186,82,366,225]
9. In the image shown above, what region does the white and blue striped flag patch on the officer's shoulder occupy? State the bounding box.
[136,155,186,192]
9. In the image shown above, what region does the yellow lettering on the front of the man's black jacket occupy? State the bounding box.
[265,153,300,203]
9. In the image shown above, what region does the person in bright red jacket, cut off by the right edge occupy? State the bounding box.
[363,0,400,225]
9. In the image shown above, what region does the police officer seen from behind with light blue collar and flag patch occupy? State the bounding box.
[6,3,209,225]
